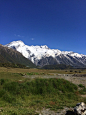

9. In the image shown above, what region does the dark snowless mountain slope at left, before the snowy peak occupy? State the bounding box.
[0,44,36,67]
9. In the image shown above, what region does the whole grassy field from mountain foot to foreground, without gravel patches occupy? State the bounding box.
[0,68,86,115]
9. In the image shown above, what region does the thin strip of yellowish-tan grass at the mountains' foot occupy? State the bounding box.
[0,67,86,75]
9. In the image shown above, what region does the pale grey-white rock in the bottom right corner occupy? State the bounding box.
[74,102,86,115]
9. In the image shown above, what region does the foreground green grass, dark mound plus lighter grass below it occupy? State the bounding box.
[0,77,83,115]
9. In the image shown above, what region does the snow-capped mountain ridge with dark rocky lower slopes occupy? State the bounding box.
[5,40,86,67]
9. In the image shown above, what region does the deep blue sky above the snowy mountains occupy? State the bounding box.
[0,0,86,55]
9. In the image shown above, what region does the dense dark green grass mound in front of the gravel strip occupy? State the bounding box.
[3,78,77,95]
